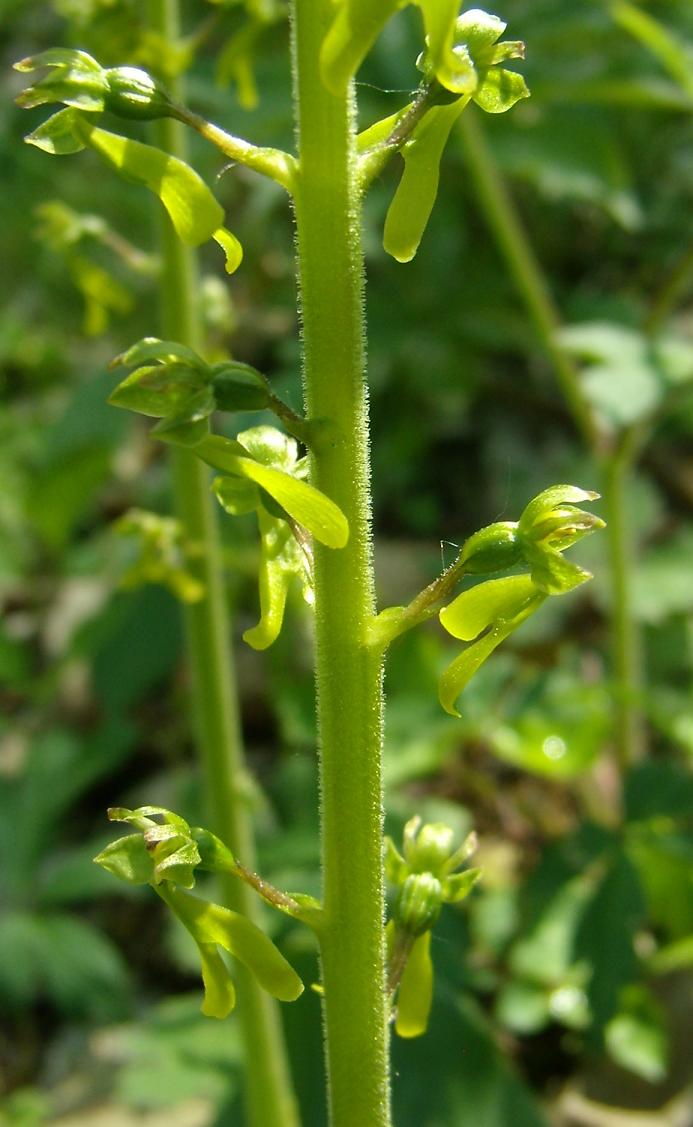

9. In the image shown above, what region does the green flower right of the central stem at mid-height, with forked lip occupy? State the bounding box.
[438,486,604,716]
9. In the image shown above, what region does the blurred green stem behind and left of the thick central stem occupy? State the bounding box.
[150,0,299,1127]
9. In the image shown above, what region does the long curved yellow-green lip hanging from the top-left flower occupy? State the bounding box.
[70,117,224,247]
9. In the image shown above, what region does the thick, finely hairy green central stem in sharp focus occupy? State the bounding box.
[292,0,390,1127]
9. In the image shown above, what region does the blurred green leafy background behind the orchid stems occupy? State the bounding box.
[0,0,693,1127]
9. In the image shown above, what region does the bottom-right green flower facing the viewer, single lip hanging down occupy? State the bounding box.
[385,816,481,1037]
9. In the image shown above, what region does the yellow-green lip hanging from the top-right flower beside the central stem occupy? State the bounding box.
[383,98,469,263]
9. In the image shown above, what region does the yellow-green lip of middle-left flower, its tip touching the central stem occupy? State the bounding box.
[195,435,349,548]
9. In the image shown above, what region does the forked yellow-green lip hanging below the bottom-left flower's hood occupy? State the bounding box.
[164,888,303,1017]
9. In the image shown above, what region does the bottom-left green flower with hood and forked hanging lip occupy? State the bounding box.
[95,806,303,1018]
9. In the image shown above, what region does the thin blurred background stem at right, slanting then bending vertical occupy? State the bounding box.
[460,110,643,770]
